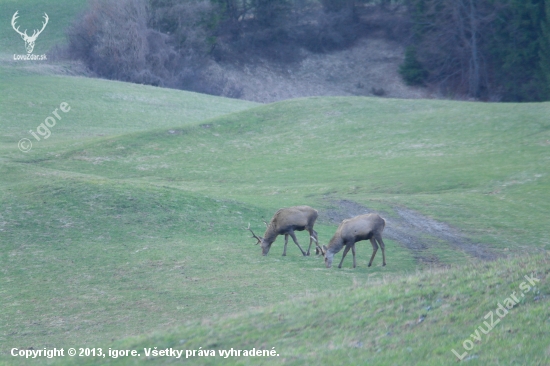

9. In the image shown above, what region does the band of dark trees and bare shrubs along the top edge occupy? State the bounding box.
[62,0,550,101]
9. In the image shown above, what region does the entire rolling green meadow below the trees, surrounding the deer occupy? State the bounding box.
[0,1,550,365]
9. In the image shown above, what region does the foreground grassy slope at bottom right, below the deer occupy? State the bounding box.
[60,255,550,365]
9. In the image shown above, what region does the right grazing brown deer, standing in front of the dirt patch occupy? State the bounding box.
[321,214,386,268]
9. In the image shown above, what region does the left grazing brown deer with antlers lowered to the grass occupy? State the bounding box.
[248,206,318,256]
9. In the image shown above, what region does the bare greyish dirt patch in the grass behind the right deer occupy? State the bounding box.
[320,200,498,264]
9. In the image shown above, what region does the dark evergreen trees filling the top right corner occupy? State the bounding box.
[400,0,550,101]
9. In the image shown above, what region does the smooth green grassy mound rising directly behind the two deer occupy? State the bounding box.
[22,98,550,263]
